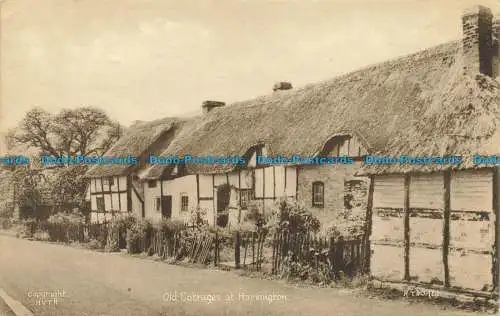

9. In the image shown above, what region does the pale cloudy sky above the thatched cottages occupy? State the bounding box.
[0,0,500,130]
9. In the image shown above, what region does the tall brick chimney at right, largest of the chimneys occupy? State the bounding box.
[462,5,494,76]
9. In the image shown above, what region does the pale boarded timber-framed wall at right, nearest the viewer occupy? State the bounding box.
[370,170,498,290]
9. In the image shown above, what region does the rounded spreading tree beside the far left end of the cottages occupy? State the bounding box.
[7,107,122,214]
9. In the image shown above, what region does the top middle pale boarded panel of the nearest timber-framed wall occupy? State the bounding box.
[410,173,444,209]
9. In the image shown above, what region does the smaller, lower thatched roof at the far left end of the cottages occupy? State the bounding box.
[85,117,182,177]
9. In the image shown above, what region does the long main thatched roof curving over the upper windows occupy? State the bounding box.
[145,42,500,178]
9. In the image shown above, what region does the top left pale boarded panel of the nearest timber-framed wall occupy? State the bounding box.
[373,176,404,208]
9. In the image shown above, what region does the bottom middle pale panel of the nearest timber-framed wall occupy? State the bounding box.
[410,247,444,282]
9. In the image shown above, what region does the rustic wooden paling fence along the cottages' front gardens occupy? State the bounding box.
[20,222,369,276]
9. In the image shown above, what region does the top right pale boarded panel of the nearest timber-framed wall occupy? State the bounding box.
[450,170,493,211]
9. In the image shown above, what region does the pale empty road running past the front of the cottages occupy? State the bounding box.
[0,236,490,316]
